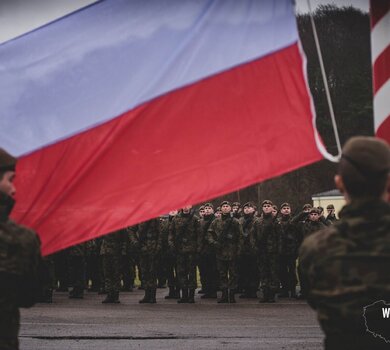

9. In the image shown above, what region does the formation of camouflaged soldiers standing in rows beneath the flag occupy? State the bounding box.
[46,200,342,304]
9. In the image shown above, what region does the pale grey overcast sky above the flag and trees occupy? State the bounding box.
[0,0,369,43]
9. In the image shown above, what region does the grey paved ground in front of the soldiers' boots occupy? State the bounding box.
[20,289,322,350]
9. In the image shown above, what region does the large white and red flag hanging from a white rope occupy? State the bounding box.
[0,0,323,254]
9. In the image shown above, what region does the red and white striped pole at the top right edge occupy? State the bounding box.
[370,0,390,143]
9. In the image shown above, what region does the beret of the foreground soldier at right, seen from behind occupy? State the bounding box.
[340,136,390,179]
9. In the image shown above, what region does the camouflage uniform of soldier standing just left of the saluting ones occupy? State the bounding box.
[279,215,299,297]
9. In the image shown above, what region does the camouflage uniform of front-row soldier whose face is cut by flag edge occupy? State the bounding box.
[168,212,200,302]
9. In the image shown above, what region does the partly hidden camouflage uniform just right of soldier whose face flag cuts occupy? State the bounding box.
[198,214,218,298]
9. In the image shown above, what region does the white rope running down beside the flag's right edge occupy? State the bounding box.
[307,0,341,162]
